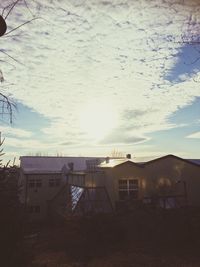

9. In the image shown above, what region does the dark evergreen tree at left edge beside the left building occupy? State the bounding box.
[0,135,23,266]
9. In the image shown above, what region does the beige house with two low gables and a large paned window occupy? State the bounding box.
[99,155,200,208]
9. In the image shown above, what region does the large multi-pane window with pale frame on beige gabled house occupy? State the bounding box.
[119,179,139,200]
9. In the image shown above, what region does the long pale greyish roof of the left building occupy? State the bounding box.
[20,156,105,173]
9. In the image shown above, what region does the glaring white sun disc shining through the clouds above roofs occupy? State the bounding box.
[80,102,117,140]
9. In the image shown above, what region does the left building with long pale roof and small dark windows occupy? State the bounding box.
[20,156,105,220]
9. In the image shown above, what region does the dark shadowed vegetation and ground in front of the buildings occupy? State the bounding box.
[7,209,200,267]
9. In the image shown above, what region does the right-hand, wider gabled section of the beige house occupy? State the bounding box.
[143,155,200,209]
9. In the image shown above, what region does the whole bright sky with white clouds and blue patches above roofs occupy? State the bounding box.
[0,0,200,161]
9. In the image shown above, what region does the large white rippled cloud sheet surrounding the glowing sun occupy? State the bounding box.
[1,0,200,155]
